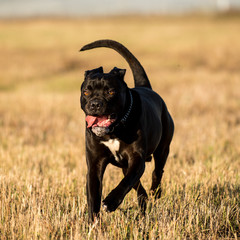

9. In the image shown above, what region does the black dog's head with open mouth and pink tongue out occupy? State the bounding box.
[81,67,127,137]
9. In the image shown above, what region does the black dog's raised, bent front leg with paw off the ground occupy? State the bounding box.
[103,156,145,212]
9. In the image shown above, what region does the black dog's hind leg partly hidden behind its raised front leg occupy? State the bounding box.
[122,168,148,214]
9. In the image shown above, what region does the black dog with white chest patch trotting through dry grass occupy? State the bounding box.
[80,40,174,220]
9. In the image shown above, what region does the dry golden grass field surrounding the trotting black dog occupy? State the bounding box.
[0,14,240,239]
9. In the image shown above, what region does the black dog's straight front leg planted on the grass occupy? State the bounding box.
[87,157,106,221]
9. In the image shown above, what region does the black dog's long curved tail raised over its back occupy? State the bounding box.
[80,39,152,89]
